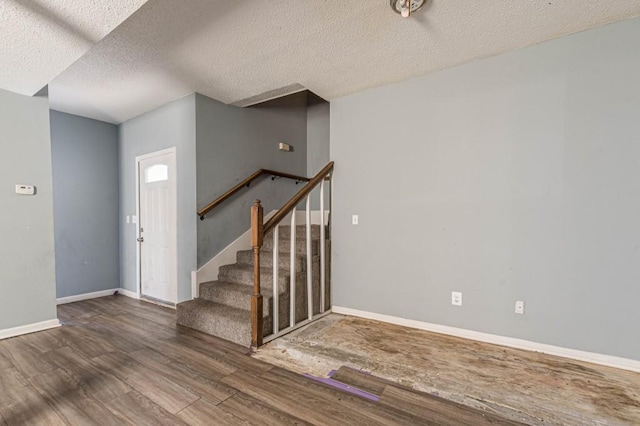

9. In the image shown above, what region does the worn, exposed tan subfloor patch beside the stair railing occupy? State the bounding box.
[253,314,640,425]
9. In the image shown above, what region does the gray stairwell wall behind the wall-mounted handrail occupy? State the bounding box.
[196,93,307,266]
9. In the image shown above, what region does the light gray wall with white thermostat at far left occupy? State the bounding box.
[0,90,56,330]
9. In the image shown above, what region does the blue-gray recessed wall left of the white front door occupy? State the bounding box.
[50,111,120,297]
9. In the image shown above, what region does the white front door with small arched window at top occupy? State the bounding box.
[137,150,178,304]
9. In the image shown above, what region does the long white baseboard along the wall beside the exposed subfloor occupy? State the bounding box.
[332,306,640,373]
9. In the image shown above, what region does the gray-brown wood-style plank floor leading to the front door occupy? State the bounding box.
[0,296,513,425]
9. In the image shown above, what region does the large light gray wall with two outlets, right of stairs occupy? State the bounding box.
[331,19,640,360]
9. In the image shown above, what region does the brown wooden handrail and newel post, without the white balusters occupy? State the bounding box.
[251,161,333,348]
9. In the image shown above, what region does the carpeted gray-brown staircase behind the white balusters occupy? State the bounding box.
[177,225,331,346]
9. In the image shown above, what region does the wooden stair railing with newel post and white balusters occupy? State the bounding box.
[251,161,334,347]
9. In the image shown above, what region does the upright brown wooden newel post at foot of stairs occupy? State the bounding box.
[251,200,264,348]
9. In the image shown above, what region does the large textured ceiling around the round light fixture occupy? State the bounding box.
[46,0,640,123]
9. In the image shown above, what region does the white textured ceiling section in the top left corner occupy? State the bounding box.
[0,0,146,96]
